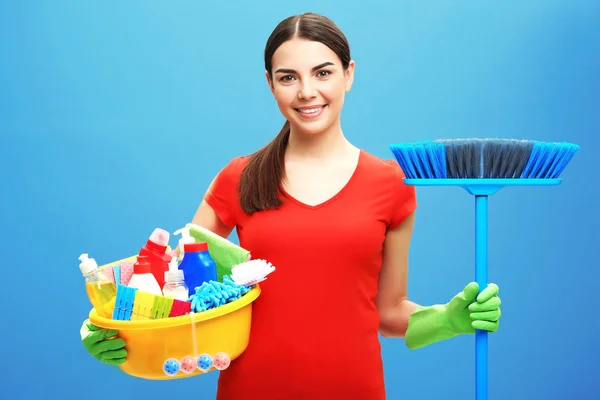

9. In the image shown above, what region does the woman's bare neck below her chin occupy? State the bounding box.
[286,121,353,158]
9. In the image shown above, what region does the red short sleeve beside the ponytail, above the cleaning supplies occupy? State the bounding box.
[204,158,242,227]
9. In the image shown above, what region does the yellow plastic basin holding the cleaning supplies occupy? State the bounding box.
[89,285,260,380]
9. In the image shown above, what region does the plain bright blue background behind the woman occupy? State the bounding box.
[0,0,600,400]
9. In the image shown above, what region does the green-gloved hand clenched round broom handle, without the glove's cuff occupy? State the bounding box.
[446,282,502,333]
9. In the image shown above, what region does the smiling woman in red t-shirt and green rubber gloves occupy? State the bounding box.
[82,13,500,400]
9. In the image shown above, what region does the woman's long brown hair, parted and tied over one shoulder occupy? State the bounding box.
[239,13,351,214]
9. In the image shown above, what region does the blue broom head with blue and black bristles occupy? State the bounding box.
[389,138,579,179]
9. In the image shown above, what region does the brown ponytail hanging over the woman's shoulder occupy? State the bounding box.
[238,121,290,214]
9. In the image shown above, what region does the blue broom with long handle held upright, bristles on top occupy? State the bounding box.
[389,138,579,400]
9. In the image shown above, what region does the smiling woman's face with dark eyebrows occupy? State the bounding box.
[267,39,354,134]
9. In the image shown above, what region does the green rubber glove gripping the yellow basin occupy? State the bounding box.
[81,319,127,365]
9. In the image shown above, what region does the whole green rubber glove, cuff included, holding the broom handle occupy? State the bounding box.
[404,282,501,349]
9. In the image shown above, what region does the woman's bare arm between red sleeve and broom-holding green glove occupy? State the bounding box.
[376,213,417,337]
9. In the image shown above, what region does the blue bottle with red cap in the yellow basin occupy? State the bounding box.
[179,242,217,296]
